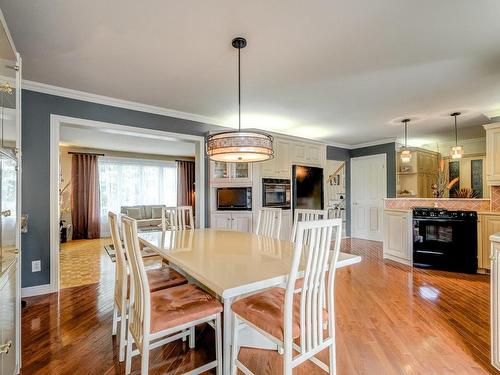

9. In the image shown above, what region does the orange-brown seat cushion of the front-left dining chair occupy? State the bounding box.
[151,284,222,333]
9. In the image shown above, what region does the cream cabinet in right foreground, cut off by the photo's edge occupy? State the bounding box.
[488,233,500,370]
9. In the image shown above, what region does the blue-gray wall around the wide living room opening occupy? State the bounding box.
[21,90,225,287]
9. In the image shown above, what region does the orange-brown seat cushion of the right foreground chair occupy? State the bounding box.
[232,288,328,341]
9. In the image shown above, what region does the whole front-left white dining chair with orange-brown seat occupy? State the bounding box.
[122,216,223,375]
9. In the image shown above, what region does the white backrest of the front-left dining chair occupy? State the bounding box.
[122,216,151,347]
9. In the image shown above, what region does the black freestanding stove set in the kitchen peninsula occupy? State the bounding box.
[413,207,477,273]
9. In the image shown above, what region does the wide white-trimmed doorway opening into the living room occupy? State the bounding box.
[50,115,205,292]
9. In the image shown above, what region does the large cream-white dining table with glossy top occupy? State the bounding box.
[138,229,361,374]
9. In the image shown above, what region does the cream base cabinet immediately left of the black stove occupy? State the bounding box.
[383,210,413,266]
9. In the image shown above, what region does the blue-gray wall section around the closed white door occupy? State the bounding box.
[326,142,396,236]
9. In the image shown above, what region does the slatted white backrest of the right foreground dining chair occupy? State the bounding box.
[285,219,342,355]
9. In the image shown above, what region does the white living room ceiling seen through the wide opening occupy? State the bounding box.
[59,123,195,157]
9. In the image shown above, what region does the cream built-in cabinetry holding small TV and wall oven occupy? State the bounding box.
[209,136,326,240]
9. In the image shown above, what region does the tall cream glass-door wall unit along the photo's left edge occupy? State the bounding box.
[0,8,21,375]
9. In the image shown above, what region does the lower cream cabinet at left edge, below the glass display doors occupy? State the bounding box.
[0,259,19,375]
